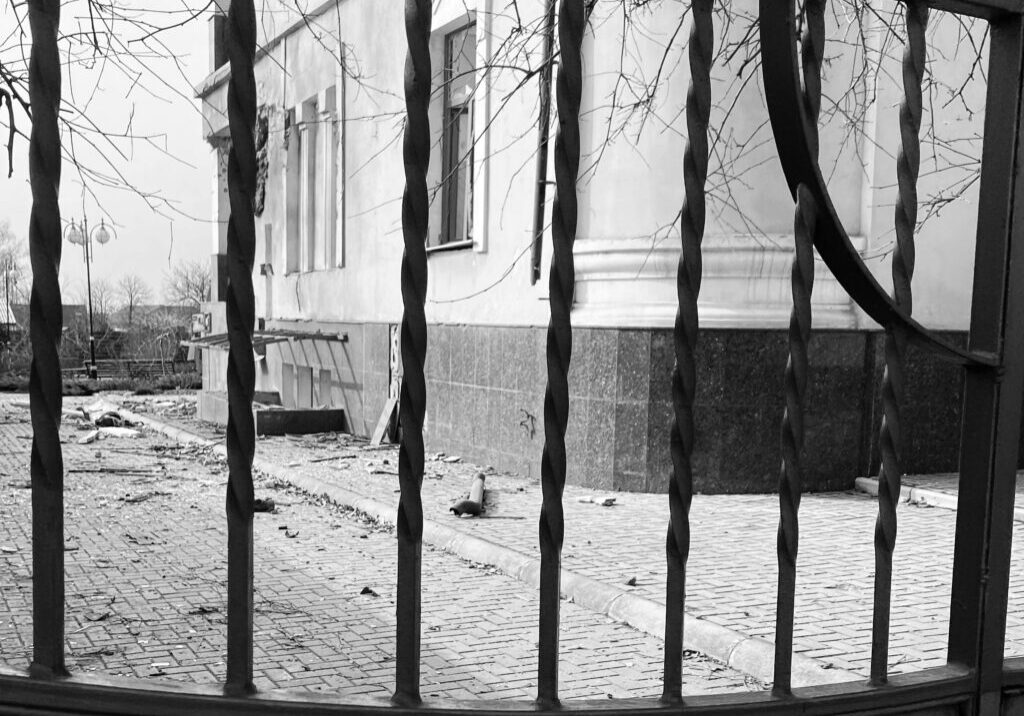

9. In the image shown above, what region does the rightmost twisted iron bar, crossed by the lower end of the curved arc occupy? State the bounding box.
[871,0,928,684]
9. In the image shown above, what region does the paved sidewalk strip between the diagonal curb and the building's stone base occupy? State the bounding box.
[112,395,1024,680]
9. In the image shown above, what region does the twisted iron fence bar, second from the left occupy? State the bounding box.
[224,0,256,693]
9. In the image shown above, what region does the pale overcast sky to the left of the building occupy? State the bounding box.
[0,0,213,303]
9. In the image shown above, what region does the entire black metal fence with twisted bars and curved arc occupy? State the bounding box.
[0,0,1024,714]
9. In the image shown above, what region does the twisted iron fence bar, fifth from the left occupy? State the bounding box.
[662,0,715,702]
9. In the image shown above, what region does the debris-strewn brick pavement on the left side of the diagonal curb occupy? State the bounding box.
[0,401,761,699]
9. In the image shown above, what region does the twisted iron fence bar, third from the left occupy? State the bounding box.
[393,0,431,706]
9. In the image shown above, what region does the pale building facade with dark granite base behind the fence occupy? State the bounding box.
[197,0,984,492]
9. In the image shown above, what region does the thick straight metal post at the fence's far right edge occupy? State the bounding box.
[948,15,1024,716]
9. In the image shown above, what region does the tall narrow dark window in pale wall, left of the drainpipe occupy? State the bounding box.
[438,24,476,244]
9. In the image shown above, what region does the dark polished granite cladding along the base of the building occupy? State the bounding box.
[239,324,991,493]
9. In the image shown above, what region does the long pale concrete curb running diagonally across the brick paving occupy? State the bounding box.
[119,409,864,686]
